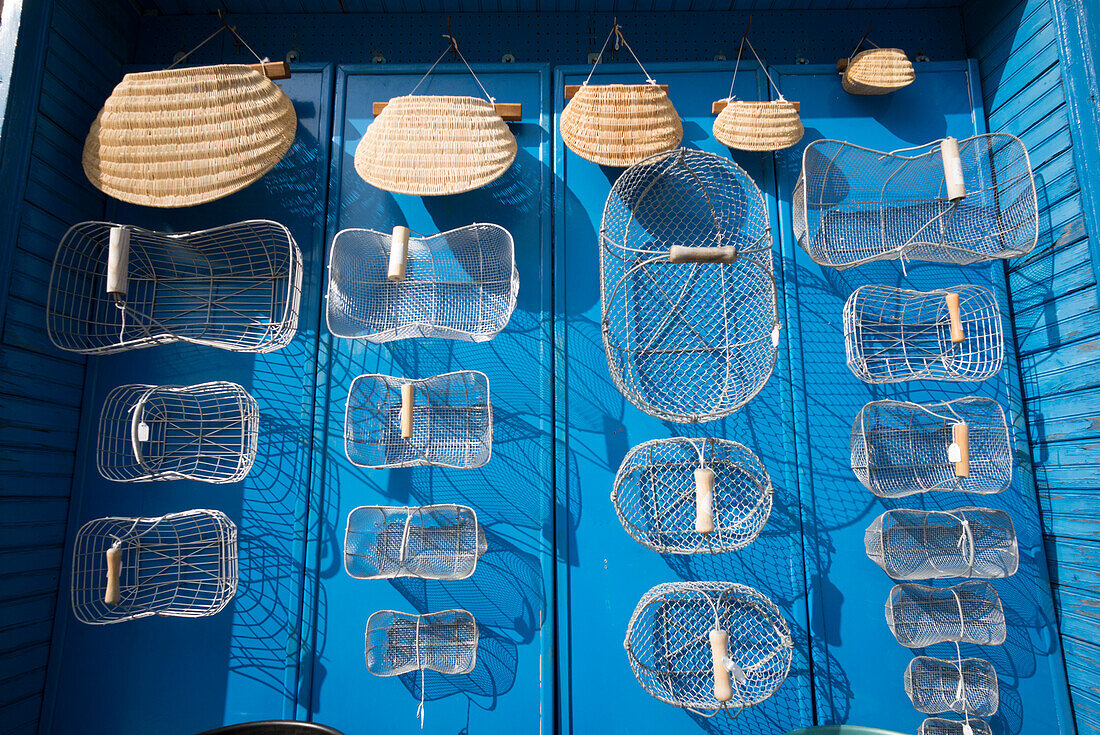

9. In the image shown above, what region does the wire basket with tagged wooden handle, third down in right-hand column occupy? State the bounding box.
[851,396,1013,497]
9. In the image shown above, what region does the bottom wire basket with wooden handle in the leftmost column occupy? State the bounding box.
[72,509,238,625]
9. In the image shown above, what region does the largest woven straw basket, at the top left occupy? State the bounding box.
[84,64,298,207]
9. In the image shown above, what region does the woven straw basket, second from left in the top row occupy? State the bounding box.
[355,95,517,196]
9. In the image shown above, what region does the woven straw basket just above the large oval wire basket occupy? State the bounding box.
[560,84,684,166]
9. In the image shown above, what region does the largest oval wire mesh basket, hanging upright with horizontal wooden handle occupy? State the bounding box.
[600,149,779,421]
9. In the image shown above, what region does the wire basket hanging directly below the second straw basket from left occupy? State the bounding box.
[326,224,519,343]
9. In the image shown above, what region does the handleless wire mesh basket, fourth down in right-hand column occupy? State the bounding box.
[864,507,1020,580]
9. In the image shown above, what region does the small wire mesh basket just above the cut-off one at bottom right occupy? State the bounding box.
[905,656,999,717]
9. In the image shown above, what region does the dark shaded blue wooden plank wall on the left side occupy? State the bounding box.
[0,0,138,734]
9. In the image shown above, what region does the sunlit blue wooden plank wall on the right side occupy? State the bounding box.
[964,0,1100,735]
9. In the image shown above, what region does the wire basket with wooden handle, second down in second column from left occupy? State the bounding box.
[344,370,493,469]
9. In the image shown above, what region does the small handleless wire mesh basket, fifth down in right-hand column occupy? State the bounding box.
[887,580,1008,648]
